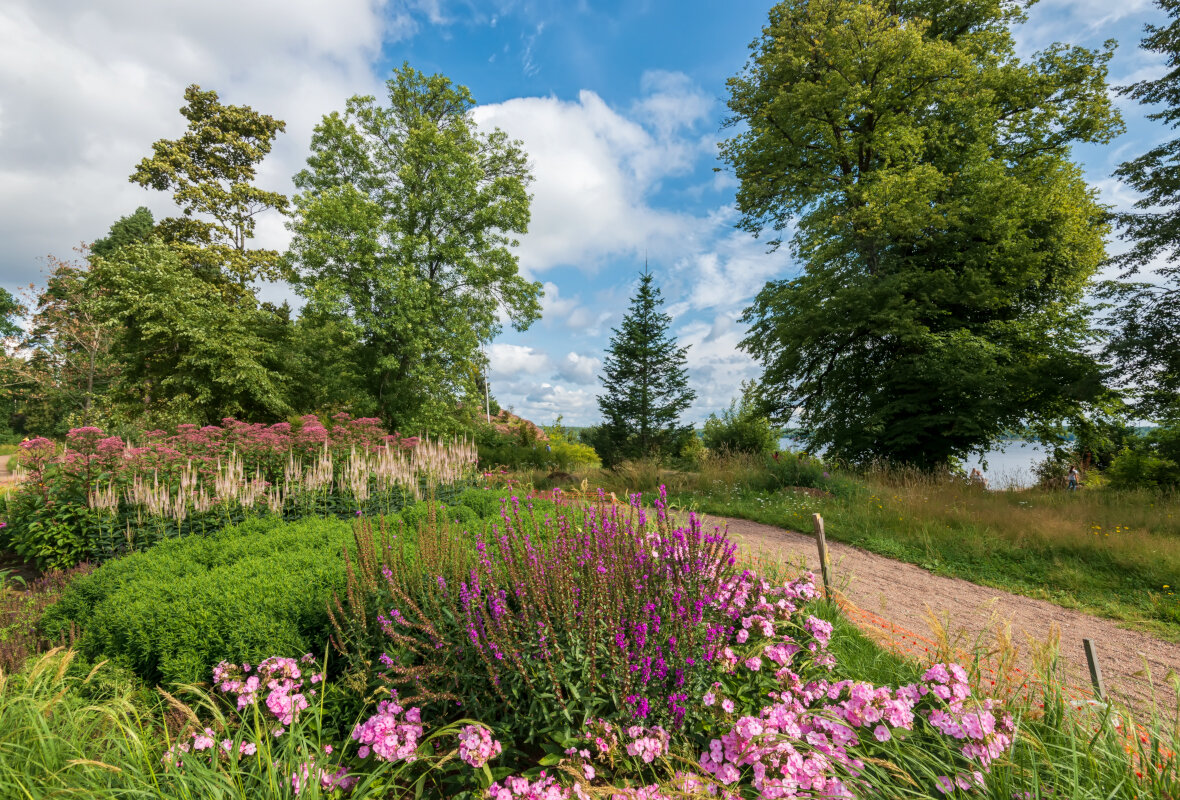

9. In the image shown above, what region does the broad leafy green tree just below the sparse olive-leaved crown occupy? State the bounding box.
[87,238,289,424]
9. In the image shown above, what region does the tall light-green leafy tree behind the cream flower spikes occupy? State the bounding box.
[290,65,540,431]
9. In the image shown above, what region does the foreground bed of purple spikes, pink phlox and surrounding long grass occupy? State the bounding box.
[0,488,1178,800]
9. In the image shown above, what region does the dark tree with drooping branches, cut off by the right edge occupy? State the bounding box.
[1106,0,1180,420]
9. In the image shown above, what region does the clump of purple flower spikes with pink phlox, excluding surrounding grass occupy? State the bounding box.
[316,497,1014,798]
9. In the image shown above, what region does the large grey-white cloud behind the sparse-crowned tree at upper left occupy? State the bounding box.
[0,0,387,284]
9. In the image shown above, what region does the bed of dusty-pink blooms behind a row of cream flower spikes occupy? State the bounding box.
[0,414,476,568]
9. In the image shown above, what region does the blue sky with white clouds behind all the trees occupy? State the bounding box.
[0,0,1167,424]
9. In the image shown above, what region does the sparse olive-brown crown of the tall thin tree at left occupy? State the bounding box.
[130,84,287,285]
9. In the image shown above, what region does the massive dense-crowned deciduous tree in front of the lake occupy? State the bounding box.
[722,0,1121,466]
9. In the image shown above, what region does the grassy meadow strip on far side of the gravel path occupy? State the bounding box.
[670,480,1180,641]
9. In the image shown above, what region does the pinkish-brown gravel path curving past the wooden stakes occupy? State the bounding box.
[708,516,1180,704]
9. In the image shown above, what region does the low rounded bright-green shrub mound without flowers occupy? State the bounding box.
[42,519,353,682]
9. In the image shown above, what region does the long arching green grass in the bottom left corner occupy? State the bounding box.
[0,651,460,800]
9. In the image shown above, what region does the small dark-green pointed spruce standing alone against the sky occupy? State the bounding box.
[591,269,696,466]
